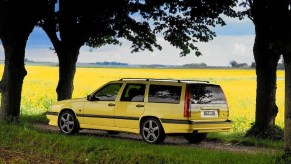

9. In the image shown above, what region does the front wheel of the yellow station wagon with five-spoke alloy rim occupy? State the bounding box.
[58,111,79,134]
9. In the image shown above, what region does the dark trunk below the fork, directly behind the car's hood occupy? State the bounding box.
[56,46,80,101]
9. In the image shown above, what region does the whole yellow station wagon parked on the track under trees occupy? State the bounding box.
[46,78,232,143]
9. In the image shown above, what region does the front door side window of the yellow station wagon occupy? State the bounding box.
[93,83,122,101]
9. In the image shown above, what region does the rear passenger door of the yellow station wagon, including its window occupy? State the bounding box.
[115,83,146,129]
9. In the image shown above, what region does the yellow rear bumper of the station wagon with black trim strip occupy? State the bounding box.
[161,119,233,133]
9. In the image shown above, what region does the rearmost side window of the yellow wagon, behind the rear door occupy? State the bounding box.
[148,85,182,104]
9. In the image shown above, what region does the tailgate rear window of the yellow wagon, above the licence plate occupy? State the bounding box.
[190,84,226,104]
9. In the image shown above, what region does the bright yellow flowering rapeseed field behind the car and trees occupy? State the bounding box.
[0,65,284,132]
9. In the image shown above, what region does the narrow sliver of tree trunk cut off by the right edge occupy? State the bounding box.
[284,54,291,152]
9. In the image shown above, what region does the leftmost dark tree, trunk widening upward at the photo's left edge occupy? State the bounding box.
[0,0,45,120]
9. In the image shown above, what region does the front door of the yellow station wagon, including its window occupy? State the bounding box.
[83,83,122,127]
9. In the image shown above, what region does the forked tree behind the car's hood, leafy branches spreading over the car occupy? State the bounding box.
[40,0,240,100]
